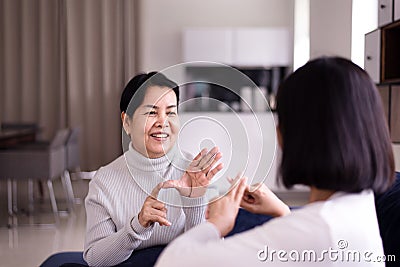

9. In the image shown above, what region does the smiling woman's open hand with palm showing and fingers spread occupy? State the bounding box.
[163,147,223,198]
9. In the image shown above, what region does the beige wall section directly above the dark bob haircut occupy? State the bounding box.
[310,0,352,58]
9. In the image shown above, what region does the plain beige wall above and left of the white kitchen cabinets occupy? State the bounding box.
[139,0,294,71]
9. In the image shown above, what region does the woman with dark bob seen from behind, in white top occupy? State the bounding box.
[157,57,394,267]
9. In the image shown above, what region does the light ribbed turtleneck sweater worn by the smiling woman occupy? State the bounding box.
[84,144,206,266]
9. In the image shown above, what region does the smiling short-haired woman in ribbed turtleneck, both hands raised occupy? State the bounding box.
[84,72,222,266]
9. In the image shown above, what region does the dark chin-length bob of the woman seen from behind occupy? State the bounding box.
[277,57,395,192]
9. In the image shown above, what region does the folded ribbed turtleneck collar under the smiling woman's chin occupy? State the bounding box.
[124,143,179,172]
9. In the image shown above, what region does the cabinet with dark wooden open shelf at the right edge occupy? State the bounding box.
[364,0,400,144]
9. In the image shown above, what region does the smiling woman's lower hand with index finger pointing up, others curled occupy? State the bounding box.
[138,183,171,228]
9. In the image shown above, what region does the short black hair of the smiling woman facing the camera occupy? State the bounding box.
[119,71,179,117]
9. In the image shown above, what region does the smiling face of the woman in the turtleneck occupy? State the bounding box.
[123,86,180,158]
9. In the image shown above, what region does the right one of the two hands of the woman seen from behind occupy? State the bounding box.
[240,183,290,217]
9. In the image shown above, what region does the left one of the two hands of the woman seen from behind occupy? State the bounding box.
[206,177,247,237]
